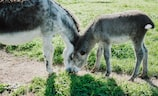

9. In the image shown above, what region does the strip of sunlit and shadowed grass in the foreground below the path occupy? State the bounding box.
[3,72,158,96]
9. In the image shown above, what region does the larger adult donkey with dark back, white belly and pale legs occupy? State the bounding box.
[0,0,79,74]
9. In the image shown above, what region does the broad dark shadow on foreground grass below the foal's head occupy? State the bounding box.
[70,74,125,96]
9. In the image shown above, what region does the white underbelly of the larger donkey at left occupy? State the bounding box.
[0,28,41,45]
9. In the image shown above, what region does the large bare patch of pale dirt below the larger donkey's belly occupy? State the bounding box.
[0,50,48,84]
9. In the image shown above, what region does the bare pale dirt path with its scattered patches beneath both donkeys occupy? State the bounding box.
[0,50,158,86]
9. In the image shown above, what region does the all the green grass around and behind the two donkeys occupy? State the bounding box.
[0,0,158,96]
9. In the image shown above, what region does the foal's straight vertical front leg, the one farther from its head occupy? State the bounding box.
[104,44,111,76]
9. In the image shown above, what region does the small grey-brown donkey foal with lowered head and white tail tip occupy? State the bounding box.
[72,10,154,81]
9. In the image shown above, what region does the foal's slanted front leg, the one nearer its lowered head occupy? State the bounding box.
[91,45,103,73]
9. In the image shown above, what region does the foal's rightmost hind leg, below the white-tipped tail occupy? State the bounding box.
[140,44,149,79]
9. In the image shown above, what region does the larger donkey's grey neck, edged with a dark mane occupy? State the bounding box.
[51,1,80,45]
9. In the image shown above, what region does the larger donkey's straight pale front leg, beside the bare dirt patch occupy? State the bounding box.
[43,36,54,74]
